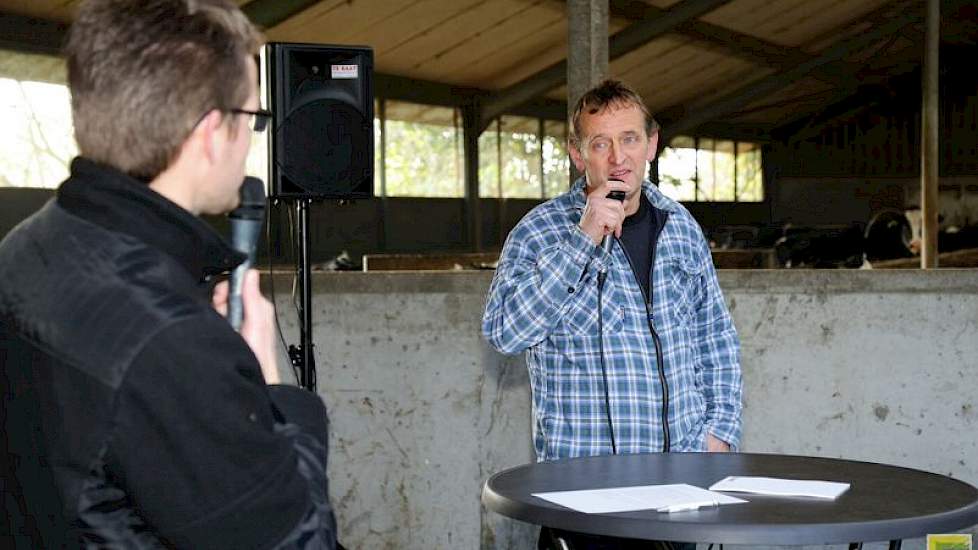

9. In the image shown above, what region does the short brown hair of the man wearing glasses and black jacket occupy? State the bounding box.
[65,0,262,180]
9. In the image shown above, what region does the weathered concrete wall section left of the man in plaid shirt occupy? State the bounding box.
[276,273,535,549]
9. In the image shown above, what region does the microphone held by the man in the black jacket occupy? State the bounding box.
[228,176,265,330]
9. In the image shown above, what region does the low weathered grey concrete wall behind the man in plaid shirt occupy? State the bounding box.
[275,270,978,549]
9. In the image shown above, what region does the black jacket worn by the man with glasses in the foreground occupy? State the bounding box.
[0,159,335,549]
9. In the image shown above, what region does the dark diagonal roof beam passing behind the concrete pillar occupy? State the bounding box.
[481,0,730,127]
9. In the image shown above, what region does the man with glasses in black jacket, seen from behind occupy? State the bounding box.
[0,0,335,549]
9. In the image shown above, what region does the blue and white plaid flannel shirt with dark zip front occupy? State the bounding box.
[482,179,742,461]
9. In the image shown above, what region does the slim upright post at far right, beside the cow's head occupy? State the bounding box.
[920,0,941,269]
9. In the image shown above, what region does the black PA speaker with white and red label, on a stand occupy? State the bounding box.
[265,43,374,199]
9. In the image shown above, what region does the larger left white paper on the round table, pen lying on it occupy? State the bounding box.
[532,483,747,514]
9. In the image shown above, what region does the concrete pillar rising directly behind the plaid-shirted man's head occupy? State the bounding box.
[567,0,608,188]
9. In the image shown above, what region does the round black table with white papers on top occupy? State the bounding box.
[482,453,978,547]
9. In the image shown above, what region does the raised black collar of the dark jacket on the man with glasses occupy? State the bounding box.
[57,157,245,280]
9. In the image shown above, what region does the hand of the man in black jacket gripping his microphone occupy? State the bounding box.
[212,269,280,384]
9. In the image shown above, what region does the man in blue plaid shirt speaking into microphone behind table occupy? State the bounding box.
[482,80,742,548]
